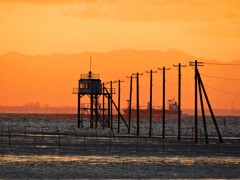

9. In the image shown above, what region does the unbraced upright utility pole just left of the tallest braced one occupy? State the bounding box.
[173,63,186,141]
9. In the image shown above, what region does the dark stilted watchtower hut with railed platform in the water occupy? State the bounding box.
[73,71,128,130]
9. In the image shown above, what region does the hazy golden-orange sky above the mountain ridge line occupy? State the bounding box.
[0,0,240,61]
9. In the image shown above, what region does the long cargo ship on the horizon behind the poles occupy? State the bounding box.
[123,99,182,120]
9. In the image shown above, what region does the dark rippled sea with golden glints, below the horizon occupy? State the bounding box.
[0,114,240,179]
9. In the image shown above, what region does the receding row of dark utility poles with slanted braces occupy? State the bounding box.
[85,60,223,143]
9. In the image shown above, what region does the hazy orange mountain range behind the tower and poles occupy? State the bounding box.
[0,48,240,109]
